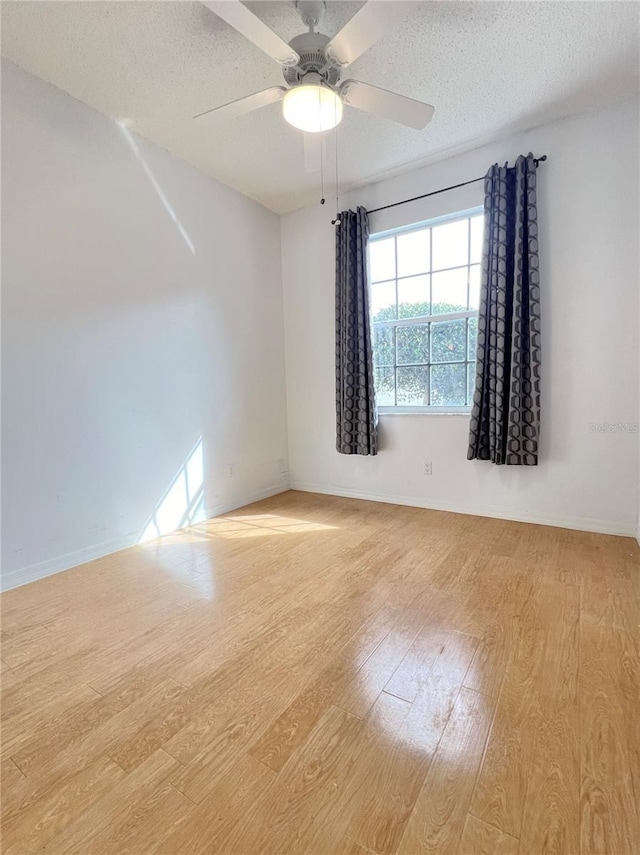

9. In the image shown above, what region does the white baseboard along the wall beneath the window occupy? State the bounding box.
[291,481,640,543]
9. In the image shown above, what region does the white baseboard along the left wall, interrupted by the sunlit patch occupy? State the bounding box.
[0,481,290,591]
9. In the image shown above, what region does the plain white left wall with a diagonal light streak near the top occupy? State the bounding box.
[2,63,287,587]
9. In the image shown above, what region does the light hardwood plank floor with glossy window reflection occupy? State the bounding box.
[1,492,640,855]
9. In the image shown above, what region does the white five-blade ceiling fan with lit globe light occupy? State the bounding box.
[194,0,434,139]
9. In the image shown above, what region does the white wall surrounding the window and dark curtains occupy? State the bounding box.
[282,100,640,535]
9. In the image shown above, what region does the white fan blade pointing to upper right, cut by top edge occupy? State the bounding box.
[325,0,410,68]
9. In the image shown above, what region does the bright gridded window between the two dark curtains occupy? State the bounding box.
[369,209,484,412]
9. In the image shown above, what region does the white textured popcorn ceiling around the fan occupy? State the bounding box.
[1,0,640,212]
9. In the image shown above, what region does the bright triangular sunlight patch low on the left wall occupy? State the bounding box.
[137,437,207,543]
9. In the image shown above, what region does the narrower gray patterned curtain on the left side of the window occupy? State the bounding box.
[336,208,378,454]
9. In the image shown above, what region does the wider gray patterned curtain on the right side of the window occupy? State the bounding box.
[467,154,540,466]
